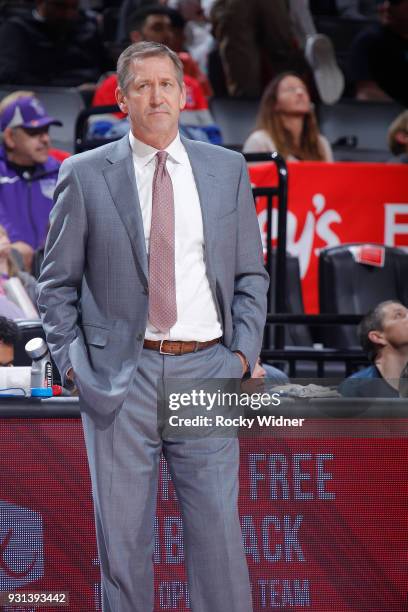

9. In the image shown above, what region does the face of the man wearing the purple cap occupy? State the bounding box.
[4,126,50,166]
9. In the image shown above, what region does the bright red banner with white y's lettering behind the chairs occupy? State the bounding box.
[249,162,408,313]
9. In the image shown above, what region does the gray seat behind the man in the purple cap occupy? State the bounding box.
[0,84,85,153]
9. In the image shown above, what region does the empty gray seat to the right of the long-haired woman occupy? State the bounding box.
[318,99,403,161]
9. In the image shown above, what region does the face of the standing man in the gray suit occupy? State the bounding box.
[116,56,186,149]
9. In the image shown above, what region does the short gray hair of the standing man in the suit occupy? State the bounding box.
[117,41,183,93]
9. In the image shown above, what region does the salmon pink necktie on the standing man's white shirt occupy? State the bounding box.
[149,151,177,332]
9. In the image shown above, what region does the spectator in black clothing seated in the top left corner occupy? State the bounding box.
[0,0,105,86]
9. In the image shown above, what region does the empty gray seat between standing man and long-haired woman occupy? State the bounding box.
[210,98,259,149]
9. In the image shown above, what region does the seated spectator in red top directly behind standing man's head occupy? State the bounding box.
[92,6,221,144]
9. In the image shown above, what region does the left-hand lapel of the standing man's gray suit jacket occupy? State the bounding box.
[103,135,148,284]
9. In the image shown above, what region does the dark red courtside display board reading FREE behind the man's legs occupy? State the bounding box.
[0,418,408,612]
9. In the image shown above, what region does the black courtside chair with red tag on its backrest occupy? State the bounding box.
[319,243,408,348]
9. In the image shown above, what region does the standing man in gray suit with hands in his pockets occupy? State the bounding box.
[38,42,268,612]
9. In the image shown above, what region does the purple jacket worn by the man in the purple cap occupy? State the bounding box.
[0,147,60,249]
